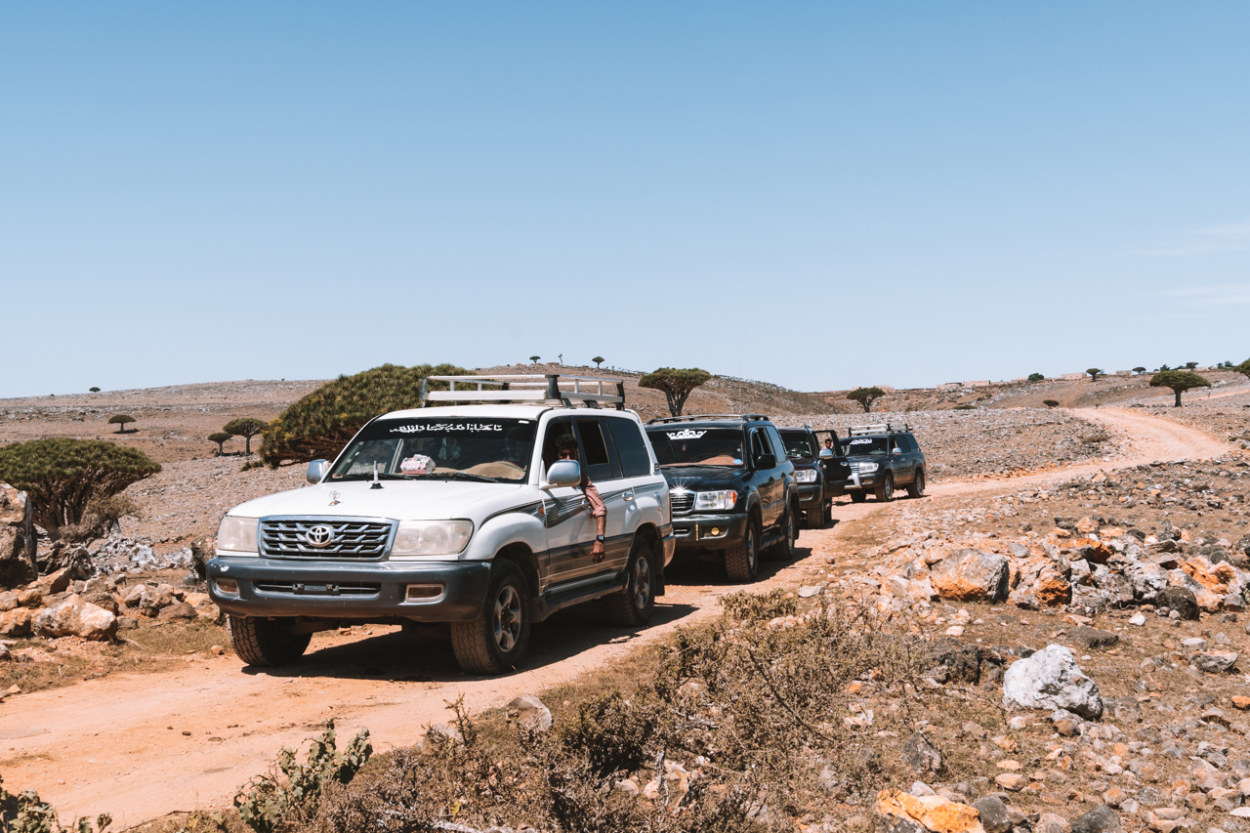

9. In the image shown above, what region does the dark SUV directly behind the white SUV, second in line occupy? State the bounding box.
[646,414,800,582]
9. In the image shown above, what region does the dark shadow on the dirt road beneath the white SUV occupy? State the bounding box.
[243,597,698,683]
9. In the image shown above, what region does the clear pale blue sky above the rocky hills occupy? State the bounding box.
[0,3,1250,396]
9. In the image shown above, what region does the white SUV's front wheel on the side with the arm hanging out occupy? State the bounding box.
[451,559,530,674]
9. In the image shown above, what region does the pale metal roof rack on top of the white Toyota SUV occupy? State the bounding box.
[420,373,625,410]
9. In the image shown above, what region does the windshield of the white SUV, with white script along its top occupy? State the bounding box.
[329,417,538,483]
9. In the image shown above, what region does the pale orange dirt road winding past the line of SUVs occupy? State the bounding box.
[0,409,1230,827]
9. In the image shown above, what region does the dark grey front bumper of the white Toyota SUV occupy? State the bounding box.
[208,557,490,622]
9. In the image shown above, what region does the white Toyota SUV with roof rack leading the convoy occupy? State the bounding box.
[208,375,674,674]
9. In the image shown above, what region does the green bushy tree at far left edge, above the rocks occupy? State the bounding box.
[0,439,160,538]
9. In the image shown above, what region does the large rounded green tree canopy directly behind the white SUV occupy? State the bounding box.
[260,364,469,467]
